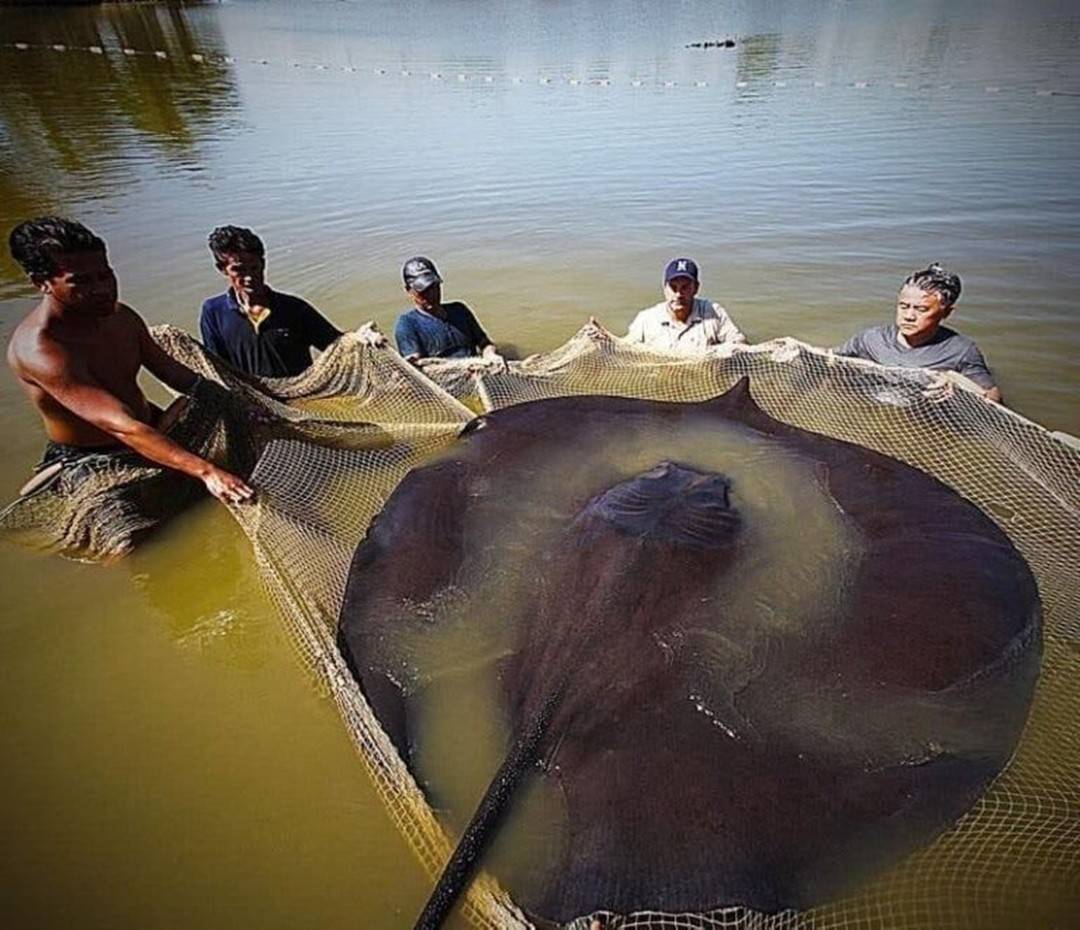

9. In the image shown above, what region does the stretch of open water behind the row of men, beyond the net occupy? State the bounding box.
[0,0,1080,432]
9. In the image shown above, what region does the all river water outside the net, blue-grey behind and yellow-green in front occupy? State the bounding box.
[0,0,1080,928]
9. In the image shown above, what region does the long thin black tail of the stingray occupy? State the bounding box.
[415,687,563,930]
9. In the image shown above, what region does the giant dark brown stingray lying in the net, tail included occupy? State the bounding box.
[339,381,1041,927]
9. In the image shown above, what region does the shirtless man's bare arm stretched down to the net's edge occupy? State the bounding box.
[19,337,254,503]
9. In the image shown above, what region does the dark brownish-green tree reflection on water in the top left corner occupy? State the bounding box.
[0,3,238,278]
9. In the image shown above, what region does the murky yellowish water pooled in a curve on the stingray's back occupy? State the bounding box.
[397,413,859,901]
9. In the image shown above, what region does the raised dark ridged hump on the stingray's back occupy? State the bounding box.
[582,461,739,549]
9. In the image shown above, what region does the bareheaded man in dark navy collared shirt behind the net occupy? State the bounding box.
[199,226,341,378]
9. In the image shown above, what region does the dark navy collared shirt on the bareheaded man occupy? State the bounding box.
[199,287,341,378]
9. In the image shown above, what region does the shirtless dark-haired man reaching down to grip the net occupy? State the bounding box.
[8,216,254,503]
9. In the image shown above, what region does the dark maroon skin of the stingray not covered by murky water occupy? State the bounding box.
[339,375,1041,920]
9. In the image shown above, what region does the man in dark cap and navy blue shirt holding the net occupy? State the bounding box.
[394,256,505,367]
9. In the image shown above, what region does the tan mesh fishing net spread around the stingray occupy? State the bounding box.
[4,326,1080,930]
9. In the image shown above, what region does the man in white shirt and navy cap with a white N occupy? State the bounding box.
[625,258,746,355]
